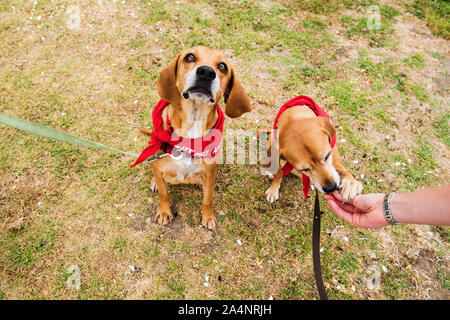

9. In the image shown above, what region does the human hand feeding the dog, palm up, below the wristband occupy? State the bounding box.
[324,190,389,228]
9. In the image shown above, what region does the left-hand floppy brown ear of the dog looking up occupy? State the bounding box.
[156,53,181,108]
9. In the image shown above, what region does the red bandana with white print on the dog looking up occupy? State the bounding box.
[131,99,225,167]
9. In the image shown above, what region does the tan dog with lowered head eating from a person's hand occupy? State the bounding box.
[266,106,363,203]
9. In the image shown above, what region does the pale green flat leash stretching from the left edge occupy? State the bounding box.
[0,114,139,158]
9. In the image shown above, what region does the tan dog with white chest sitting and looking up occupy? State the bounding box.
[151,46,252,229]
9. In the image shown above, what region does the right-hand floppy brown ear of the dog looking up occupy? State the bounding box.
[223,68,252,118]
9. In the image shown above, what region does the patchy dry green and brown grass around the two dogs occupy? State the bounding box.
[0,0,449,299]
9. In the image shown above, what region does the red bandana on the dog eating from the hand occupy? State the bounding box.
[273,96,336,199]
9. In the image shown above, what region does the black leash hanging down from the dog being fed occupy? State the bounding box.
[313,189,328,300]
